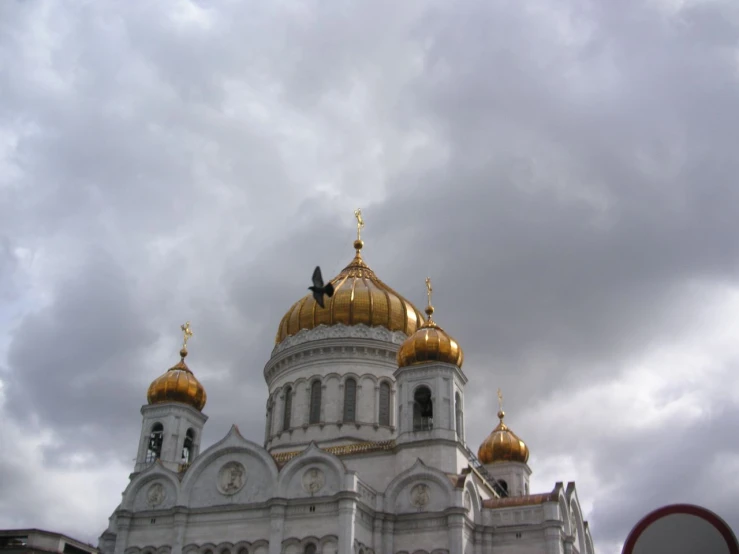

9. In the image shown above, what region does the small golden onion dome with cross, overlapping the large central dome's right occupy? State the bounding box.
[398,278,464,367]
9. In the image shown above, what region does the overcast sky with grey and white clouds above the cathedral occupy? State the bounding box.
[0,0,739,554]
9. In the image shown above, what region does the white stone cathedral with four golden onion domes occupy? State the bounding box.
[99,210,594,554]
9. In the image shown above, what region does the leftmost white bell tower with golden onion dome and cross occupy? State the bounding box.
[134,322,208,472]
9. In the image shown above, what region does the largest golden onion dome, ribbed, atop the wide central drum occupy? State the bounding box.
[275,239,423,344]
